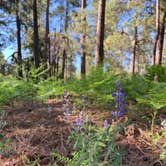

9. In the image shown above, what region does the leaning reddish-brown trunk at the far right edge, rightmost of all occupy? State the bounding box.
[156,12,166,65]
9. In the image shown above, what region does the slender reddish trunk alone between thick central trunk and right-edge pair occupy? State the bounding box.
[130,27,137,74]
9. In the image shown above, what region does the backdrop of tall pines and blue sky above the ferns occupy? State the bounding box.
[0,0,166,79]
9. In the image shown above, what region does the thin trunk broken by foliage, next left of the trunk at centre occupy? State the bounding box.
[62,0,69,79]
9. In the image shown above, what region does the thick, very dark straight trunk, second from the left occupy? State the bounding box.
[33,0,39,68]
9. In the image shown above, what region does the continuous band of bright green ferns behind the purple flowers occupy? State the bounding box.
[0,70,166,109]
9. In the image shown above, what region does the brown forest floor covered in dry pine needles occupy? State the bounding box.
[0,100,166,166]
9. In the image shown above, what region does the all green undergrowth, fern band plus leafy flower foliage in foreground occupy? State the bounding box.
[0,67,166,166]
